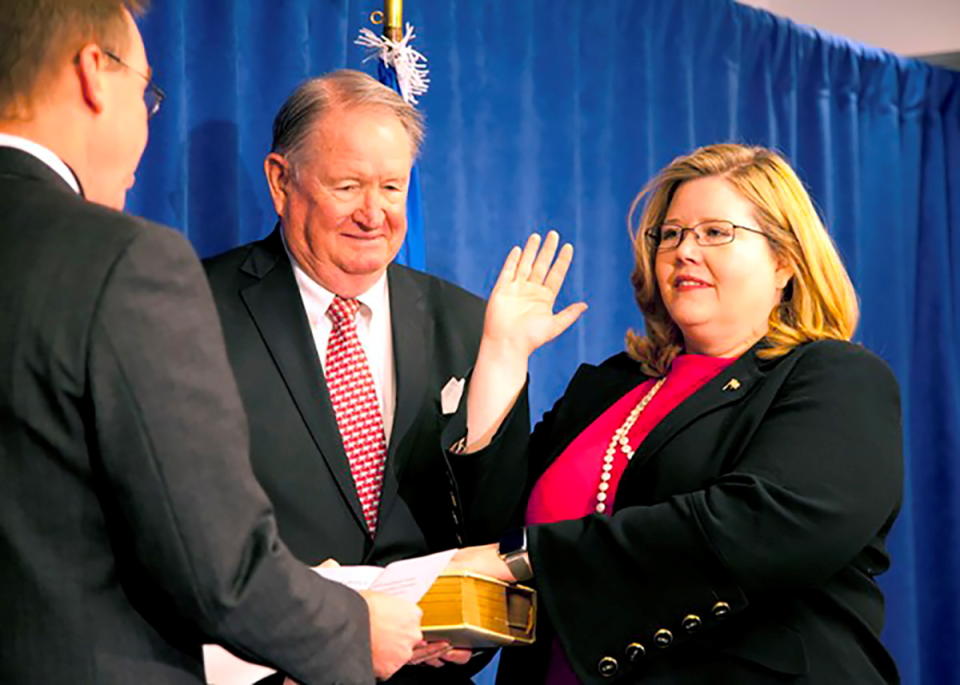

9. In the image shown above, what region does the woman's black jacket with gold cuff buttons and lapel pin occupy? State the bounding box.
[492,341,902,684]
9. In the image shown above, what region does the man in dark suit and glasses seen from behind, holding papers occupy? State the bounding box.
[0,0,420,685]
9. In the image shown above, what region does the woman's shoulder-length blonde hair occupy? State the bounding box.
[627,143,859,376]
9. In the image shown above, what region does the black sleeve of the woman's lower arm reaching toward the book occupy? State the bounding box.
[528,343,902,678]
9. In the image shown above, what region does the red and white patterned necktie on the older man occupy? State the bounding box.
[325,296,387,533]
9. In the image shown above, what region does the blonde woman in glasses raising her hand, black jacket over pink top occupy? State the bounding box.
[456,144,902,685]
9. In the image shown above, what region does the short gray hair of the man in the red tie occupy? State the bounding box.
[270,69,424,159]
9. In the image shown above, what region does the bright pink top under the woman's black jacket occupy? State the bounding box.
[526,354,735,685]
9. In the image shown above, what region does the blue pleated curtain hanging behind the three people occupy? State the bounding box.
[129,0,960,685]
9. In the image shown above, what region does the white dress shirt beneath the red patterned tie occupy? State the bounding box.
[281,240,397,445]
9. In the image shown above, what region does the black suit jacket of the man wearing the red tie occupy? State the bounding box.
[204,228,529,682]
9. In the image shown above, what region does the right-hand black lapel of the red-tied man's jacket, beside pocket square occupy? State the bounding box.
[380,264,433,528]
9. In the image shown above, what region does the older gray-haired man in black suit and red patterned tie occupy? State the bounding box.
[205,70,529,683]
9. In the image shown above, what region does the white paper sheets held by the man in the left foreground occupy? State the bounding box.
[203,549,456,685]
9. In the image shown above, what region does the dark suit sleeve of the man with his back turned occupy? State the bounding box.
[88,228,373,683]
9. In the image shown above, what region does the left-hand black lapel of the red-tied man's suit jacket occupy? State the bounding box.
[240,228,367,532]
